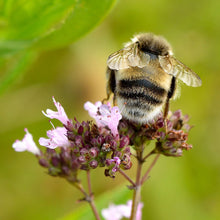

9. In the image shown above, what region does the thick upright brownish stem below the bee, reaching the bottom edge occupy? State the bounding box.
[130,146,144,220]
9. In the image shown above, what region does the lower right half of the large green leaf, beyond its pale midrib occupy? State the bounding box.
[34,0,116,49]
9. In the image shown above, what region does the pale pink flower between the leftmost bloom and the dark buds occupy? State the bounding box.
[39,127,70,149]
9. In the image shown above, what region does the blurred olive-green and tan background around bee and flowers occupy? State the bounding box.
[0,0,220,220]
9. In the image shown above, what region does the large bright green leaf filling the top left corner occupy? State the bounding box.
[0,0,116,55]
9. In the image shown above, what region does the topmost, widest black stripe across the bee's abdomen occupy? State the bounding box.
[119,79,166,96]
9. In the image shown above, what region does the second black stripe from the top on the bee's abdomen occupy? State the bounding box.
[118,91,162,105]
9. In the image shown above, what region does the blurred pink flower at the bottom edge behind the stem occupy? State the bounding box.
[102,200,143,220]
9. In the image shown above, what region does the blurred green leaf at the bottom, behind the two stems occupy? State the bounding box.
[61,185,132,220]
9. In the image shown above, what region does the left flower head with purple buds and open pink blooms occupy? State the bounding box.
[13,98,132,182]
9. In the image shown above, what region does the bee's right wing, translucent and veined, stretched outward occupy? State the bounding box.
[159,56,202,87]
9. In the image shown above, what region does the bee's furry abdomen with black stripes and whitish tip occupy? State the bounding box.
[115,78,167,124]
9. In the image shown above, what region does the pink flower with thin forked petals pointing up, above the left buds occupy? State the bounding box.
[42,97,70,126]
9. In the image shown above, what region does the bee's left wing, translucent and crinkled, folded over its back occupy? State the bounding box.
[107,43,150,70]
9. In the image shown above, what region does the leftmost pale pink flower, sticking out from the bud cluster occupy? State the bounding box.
[12,128,40,155]
